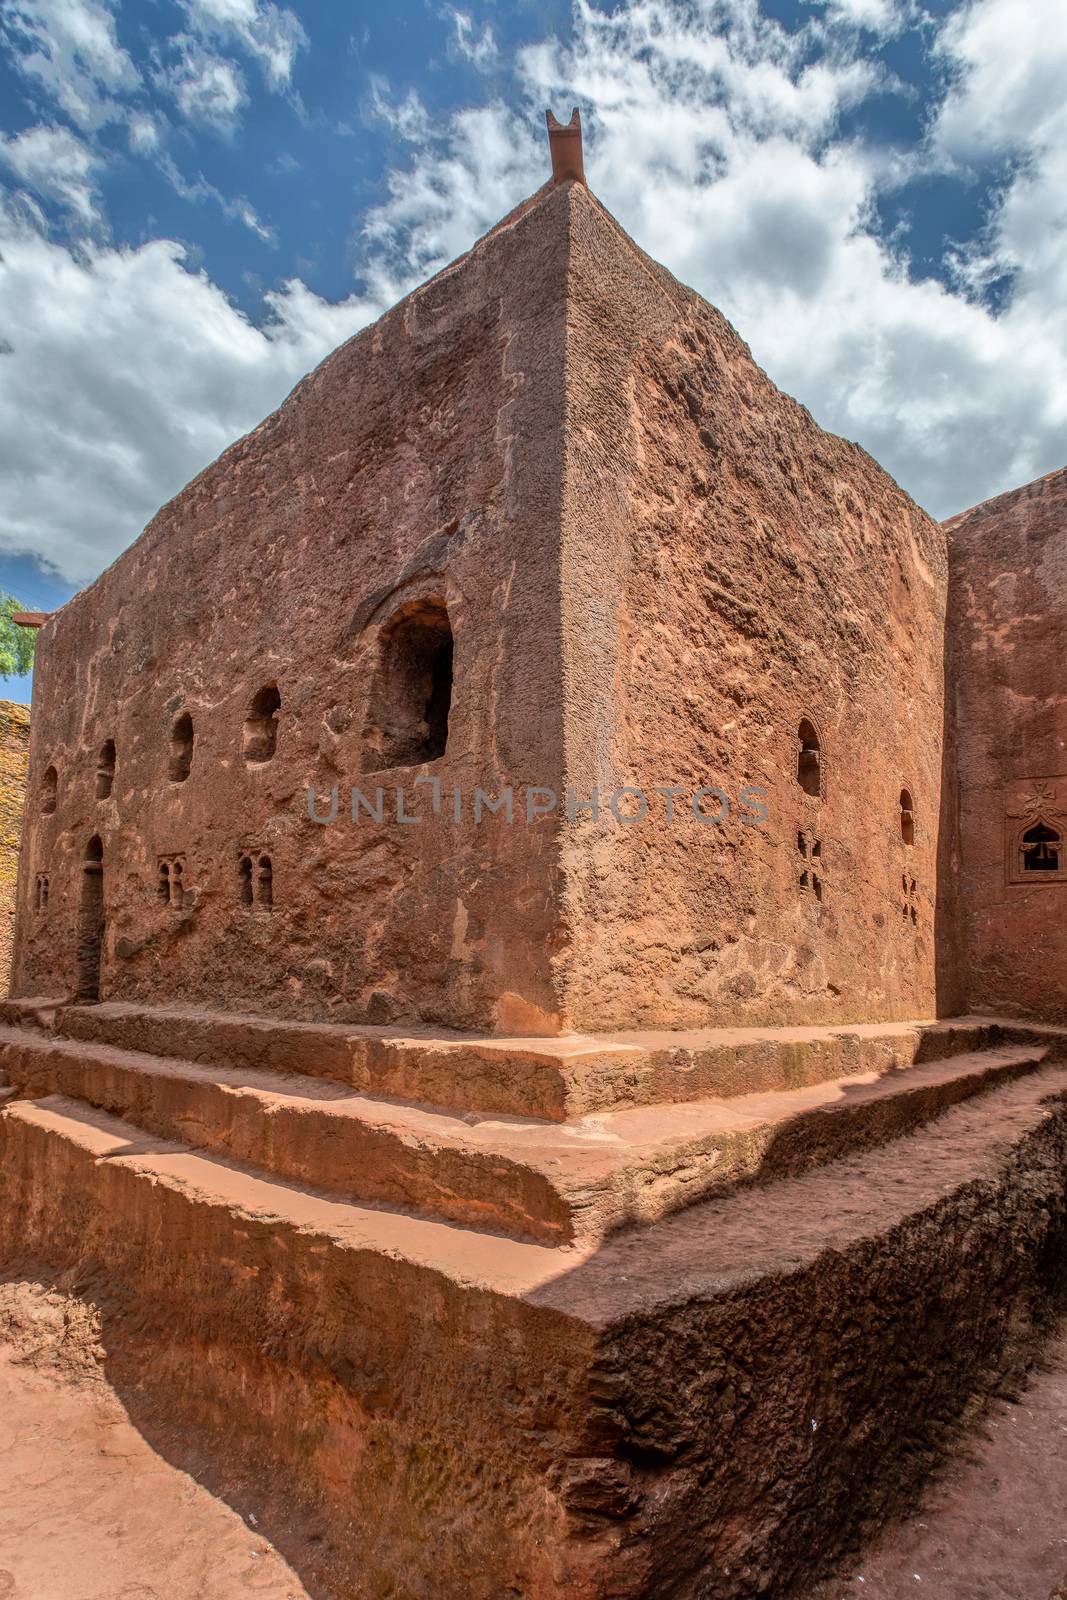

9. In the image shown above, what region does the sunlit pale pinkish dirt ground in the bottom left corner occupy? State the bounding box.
[0,1283,307,1600]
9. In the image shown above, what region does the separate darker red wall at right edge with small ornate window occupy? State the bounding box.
[945,469,1067,1021]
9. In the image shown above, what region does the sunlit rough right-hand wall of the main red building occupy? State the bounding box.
[563,189,947,1027]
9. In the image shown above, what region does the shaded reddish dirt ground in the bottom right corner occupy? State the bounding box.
[811,1326,1067,1600]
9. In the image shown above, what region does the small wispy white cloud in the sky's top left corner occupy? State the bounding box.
[0,0,141,131]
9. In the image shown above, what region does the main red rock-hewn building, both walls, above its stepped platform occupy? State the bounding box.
[16,182,945,1034]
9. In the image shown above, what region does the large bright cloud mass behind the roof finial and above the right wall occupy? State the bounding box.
[351,0,1067,515]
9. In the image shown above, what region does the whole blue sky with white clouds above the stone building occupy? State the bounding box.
[0,0,1067,699]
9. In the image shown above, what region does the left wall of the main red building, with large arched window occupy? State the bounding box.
[14,181,566,1032]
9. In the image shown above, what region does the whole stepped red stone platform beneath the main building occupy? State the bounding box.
[0,1000,1067,1600]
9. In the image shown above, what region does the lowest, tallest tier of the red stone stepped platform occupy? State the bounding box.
[0,1069,1067,1600]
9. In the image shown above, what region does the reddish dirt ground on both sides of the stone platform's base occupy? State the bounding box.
[0,1283,1067,1600]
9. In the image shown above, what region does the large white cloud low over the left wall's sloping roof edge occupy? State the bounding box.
[0,200,382,582]
